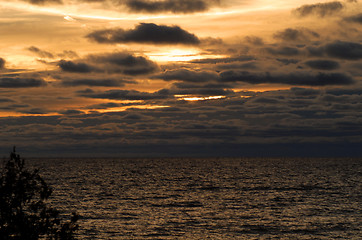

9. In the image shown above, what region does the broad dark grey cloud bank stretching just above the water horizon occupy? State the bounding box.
[0,88,362,156]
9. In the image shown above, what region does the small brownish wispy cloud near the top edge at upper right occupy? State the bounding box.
[294,1,343,17]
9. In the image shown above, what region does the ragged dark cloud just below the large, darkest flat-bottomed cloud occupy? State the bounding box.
[88,52,159,75]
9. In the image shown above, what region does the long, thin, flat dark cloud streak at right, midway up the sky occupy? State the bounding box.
[220,71,355,86]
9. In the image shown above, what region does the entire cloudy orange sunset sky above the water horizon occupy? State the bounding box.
[0,0,362,157]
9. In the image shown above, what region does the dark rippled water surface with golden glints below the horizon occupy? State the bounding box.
[28,158,362,239]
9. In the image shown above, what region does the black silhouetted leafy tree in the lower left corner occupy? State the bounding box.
[0,147,78,240]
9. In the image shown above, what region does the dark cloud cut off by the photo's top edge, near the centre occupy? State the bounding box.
[126,0,217,13]
